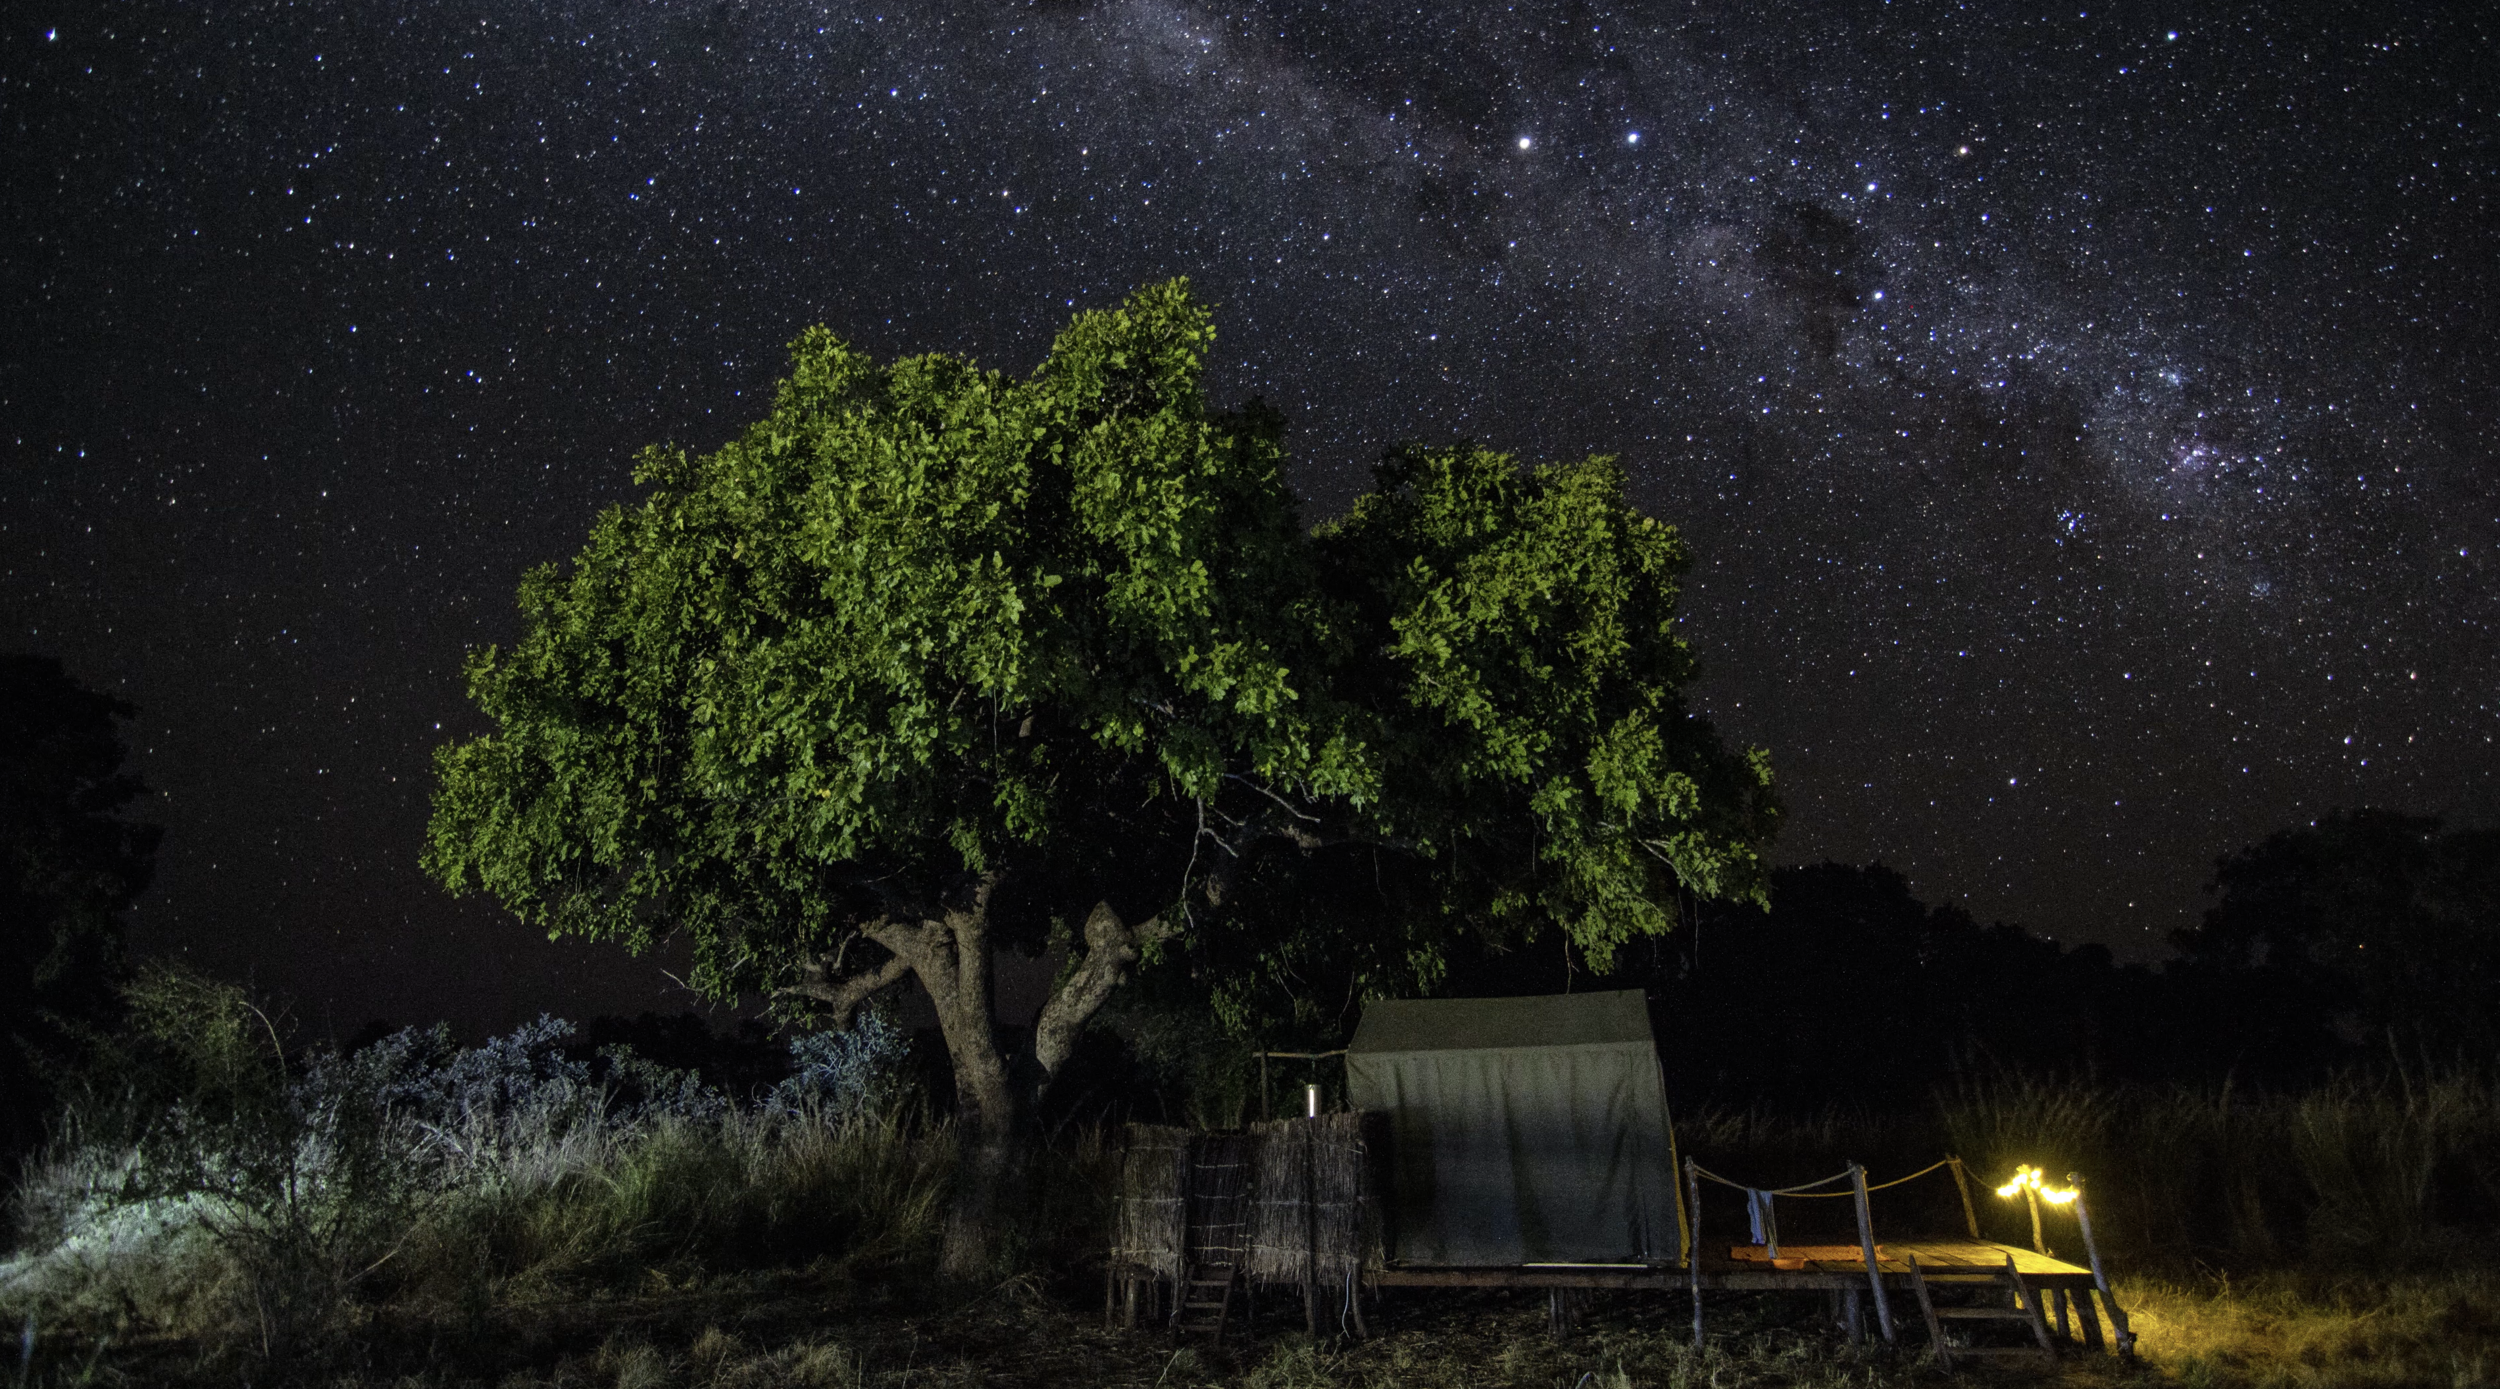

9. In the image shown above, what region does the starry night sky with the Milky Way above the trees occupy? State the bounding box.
[0,0,2500,1032]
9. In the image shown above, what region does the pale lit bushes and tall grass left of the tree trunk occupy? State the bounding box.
[0,969,953,1359]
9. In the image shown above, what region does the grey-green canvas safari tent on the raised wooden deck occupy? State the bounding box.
[1345,989,1685,1267]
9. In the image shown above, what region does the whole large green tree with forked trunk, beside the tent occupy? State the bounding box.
[428,282,1775,1267]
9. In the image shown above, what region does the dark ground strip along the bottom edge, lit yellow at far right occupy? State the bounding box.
[53,1272,2500,1389]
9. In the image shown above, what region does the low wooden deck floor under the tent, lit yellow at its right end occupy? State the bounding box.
[1370,1239,2093,1292]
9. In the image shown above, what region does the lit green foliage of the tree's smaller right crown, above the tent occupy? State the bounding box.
[1323,447,1778,969]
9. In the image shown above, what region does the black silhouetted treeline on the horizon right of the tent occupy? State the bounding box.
[1453,809,2500,1104]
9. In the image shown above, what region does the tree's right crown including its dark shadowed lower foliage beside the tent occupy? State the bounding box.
[1123,447,1780,1054]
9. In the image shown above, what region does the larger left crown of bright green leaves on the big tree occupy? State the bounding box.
[428,285,1368,994]
